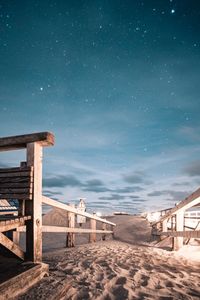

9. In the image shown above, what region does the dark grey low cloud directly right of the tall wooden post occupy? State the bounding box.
[43,175,82,188]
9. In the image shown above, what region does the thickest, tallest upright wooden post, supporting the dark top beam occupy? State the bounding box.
[25,142,42,262]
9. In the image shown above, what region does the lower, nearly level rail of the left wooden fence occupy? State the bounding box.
[42,225,113,234]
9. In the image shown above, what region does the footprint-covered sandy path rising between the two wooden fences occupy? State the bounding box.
[18,212,200,300]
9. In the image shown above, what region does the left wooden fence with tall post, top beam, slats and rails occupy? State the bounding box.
[0,132,115,262]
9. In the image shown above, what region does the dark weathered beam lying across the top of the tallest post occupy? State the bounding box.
[0,132,54,151]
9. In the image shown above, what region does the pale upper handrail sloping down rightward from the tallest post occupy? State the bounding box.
[42,196,116,226]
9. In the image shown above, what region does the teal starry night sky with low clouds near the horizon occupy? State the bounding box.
[0,0,200,214]
